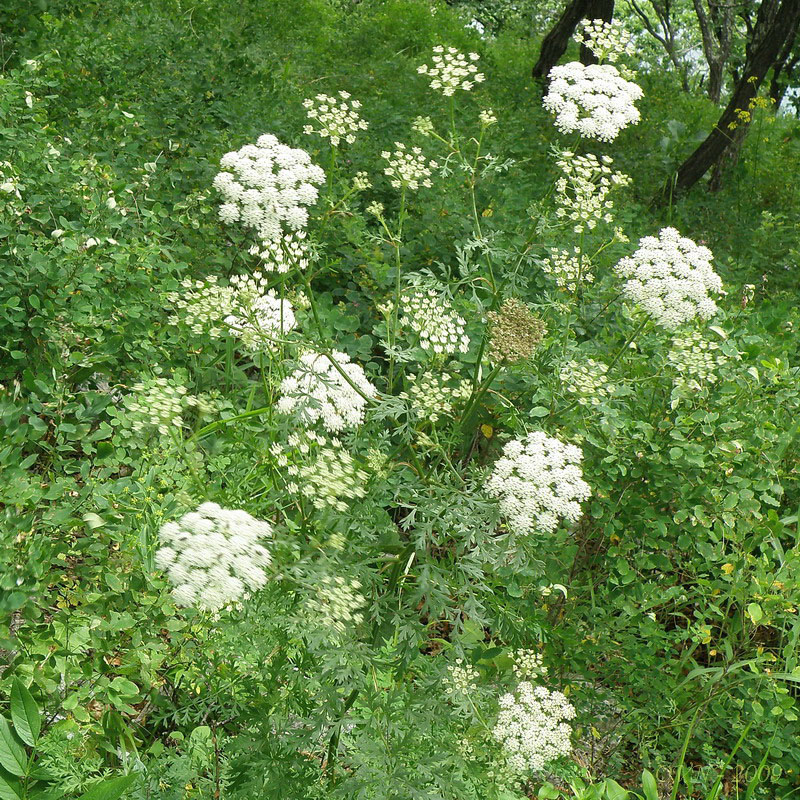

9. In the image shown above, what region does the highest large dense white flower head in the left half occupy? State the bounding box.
[214,133,325,242]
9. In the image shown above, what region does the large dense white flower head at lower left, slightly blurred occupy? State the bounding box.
[155,503,272,611]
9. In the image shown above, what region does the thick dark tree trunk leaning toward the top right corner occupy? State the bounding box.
[662,0,800,202]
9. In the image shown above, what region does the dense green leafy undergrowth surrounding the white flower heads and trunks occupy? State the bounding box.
[0,0,800,800]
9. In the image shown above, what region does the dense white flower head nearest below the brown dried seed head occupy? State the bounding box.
[486,431,591,534]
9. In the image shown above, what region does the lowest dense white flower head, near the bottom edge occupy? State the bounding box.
[492,681,575,774]
